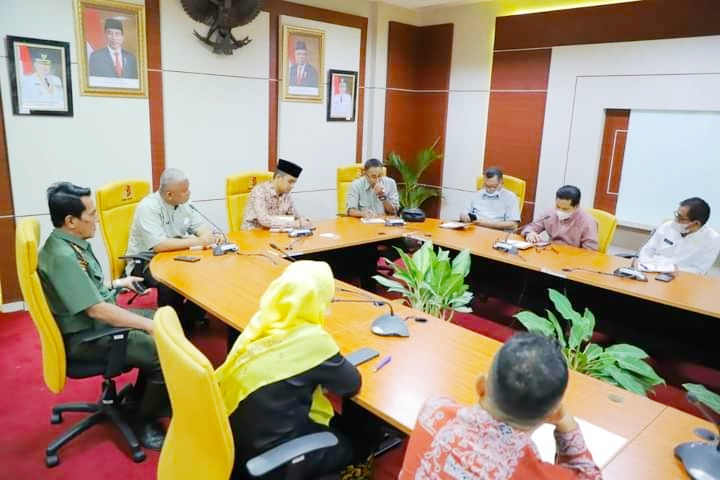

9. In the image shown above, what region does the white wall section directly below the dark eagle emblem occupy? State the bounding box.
[160,0,271,229]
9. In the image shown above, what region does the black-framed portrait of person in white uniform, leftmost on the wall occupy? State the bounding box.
[7,35,73,116]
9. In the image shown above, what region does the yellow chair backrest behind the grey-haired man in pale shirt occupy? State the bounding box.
[95,179,150,278]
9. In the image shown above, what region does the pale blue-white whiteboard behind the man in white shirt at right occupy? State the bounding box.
[615,110,720,229]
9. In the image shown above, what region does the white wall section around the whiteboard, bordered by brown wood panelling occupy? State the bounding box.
[536,36,720,218]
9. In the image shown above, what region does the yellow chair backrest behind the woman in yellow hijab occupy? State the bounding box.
[153,307,235,480]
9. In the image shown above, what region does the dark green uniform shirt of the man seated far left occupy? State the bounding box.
[38,229,116,335]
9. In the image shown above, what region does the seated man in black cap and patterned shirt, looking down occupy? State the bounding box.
[242,159,312,230]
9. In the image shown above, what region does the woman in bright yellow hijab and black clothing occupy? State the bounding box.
[215,261,361,479]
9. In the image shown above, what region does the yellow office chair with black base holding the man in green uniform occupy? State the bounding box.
[15,217,145,467]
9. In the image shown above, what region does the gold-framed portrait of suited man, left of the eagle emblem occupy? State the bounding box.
[75,0,147,97]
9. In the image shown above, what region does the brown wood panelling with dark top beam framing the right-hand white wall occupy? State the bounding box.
[485,0,720,222]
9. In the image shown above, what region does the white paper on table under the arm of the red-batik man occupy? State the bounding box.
[531,418,627,468]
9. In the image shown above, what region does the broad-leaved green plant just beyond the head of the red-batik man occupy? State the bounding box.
[515,288,665,395]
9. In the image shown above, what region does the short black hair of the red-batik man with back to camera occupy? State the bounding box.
[488,332,568,426]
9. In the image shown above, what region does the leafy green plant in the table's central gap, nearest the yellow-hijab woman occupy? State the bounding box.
[373,242,472,321]
